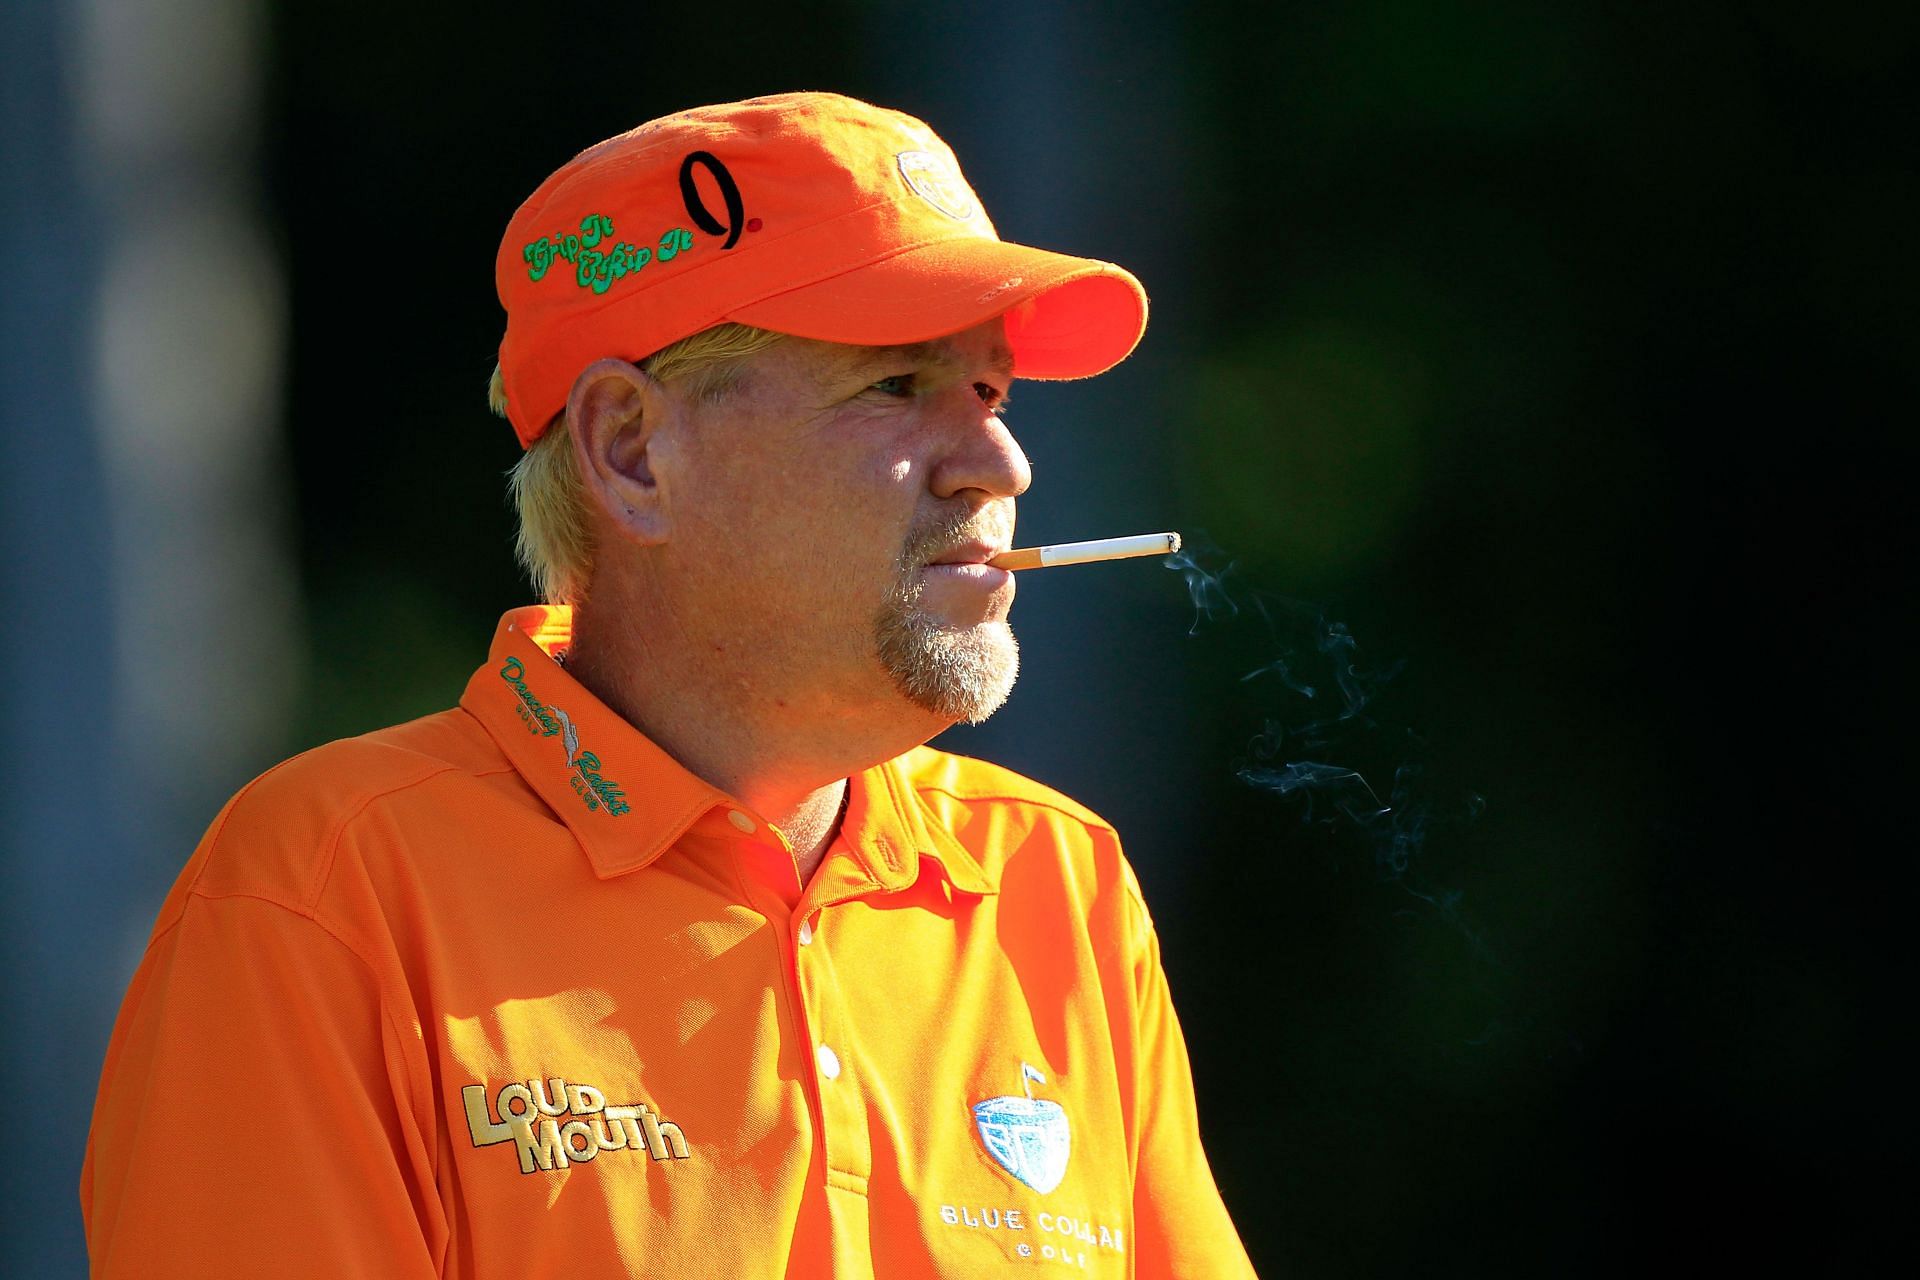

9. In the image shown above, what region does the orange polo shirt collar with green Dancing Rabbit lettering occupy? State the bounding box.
[461,604,996,894]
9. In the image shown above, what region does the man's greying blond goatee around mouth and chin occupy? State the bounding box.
[874,514,1020,723]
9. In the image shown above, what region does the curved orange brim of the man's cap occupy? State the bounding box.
[726,236,1146,378]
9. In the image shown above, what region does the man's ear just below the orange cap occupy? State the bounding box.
[566,359,676,545]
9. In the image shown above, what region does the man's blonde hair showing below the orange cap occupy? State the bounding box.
[503,324,781,604]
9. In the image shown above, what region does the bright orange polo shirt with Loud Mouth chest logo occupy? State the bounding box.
[81,608,1252,1280]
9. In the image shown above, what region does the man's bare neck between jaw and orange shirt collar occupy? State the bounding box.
[566,603,931,885]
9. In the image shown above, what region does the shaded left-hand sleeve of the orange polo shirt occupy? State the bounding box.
[81,894,445,1280]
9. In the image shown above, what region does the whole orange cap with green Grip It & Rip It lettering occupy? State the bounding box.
[493,94,1146,447]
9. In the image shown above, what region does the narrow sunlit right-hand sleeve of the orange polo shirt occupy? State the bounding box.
[1133,902,1254,1280]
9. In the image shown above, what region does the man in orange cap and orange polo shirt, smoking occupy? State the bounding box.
[81,94,1250,1276]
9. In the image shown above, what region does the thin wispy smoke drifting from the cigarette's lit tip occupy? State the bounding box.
[1162,537,1492,960]
